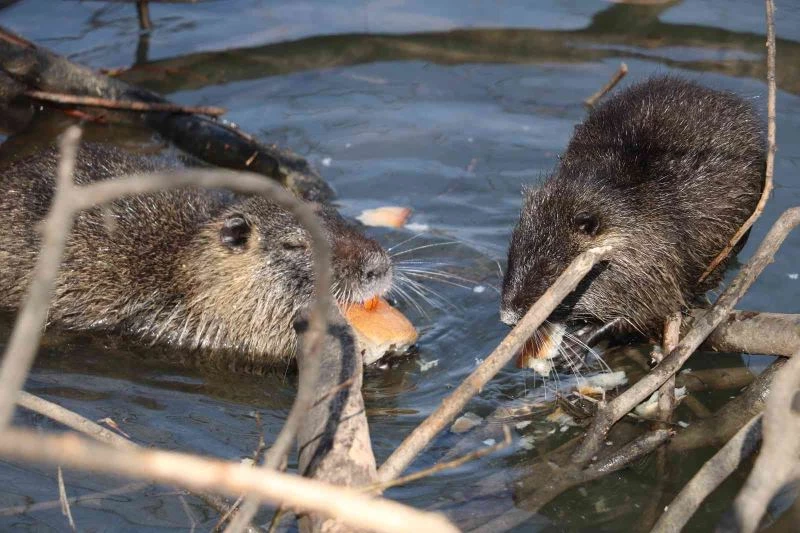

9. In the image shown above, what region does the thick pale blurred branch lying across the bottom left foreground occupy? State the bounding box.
[0,428,458,533]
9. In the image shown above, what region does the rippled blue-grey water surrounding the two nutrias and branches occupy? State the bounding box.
[0,0,800,531]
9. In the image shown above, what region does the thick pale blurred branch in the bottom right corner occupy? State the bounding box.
[733,351,800,533]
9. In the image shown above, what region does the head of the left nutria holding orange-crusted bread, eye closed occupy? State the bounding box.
[176,197,393,362]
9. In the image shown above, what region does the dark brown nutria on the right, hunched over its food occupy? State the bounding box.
[500,77,766,370]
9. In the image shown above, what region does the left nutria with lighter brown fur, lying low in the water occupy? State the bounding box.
[0,145,392,366]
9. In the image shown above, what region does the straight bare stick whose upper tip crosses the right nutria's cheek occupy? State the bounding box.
[378,246,611,482]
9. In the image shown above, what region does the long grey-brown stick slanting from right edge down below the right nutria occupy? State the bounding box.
[572,207,800,465]
